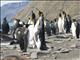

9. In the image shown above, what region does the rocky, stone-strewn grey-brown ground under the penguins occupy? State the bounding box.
[0,34,80,60]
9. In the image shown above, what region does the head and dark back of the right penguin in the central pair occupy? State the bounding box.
[39,11,47,50]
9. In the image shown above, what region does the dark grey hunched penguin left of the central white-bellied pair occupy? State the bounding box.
[15,26,28,52]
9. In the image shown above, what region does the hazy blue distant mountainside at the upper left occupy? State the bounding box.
[0,2,27,25]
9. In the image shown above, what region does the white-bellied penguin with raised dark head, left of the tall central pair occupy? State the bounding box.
[28,11,36,48]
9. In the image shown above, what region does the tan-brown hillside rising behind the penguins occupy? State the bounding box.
[15,1,80,20]
